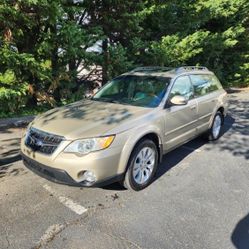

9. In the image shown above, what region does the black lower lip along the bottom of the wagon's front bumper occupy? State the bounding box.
[21,153,123,187]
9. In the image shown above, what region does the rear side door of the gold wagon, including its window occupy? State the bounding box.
[190,74,221,133]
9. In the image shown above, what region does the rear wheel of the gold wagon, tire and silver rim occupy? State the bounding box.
[207,111,224,141]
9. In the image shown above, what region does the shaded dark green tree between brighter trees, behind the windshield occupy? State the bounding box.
[83,0,144,84]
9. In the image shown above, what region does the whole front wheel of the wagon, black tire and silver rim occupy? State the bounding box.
[122,139,158,191]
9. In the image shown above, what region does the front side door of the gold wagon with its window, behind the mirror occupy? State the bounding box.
[164,76,198,150]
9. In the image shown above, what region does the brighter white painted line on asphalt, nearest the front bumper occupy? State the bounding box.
[43,184,87,215]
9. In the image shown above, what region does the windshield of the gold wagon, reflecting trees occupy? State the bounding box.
[92,75,170,107]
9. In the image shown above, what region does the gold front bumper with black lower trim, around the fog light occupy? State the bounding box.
[21,129,125,186]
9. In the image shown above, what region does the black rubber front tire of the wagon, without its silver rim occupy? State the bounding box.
[125,139,158,191]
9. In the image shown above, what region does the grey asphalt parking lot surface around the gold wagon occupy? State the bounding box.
[0,91,249,249]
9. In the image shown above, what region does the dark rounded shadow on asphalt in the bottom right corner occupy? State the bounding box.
[231,214,249,249]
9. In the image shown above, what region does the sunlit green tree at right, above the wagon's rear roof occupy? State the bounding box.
[142,0,249,85]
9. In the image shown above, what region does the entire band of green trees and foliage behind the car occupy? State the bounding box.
[0,0,249,116]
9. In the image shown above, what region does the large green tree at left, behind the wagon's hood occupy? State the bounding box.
[0,0,101,110]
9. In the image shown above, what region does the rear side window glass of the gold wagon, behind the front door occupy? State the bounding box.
[190,74,222,97]
